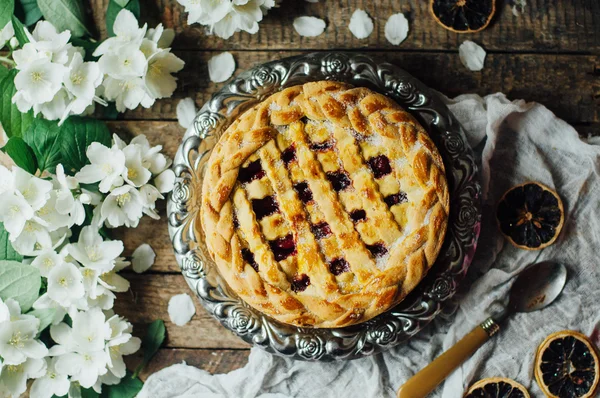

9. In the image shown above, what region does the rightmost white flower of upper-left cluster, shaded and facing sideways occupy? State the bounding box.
[145,50,185,98]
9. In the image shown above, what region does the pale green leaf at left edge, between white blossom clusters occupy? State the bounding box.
[0,261,42,312]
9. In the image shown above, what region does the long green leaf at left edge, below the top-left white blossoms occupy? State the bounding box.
[0,69,34,137]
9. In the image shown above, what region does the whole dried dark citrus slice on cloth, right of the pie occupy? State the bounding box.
[496,182,564,250]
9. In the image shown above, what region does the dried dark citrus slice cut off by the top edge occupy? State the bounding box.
[429,0,496,33]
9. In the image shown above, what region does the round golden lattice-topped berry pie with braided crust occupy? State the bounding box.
[201,81,449,328]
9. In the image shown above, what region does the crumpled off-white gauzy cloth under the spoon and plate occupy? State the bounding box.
[139,93,600,398]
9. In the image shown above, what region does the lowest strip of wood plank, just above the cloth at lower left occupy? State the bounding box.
[125,348,250,381]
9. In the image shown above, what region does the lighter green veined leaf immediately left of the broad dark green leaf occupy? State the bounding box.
[23,119,63,173]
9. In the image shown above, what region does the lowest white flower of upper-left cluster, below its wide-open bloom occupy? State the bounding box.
[103,77,154,112]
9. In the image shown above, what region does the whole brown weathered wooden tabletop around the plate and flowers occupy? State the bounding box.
[88,0,600,378]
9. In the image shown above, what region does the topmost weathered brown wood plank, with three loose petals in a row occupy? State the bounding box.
[89,0,600,52]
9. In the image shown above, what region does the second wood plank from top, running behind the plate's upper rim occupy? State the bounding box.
[113,51,600,122]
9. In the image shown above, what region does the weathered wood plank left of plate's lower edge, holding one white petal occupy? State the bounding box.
[114,273,248,348]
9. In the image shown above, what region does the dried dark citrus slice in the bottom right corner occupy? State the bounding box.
[535,330,600,398]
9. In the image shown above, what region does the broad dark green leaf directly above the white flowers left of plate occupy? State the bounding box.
[60,117,111,175]
